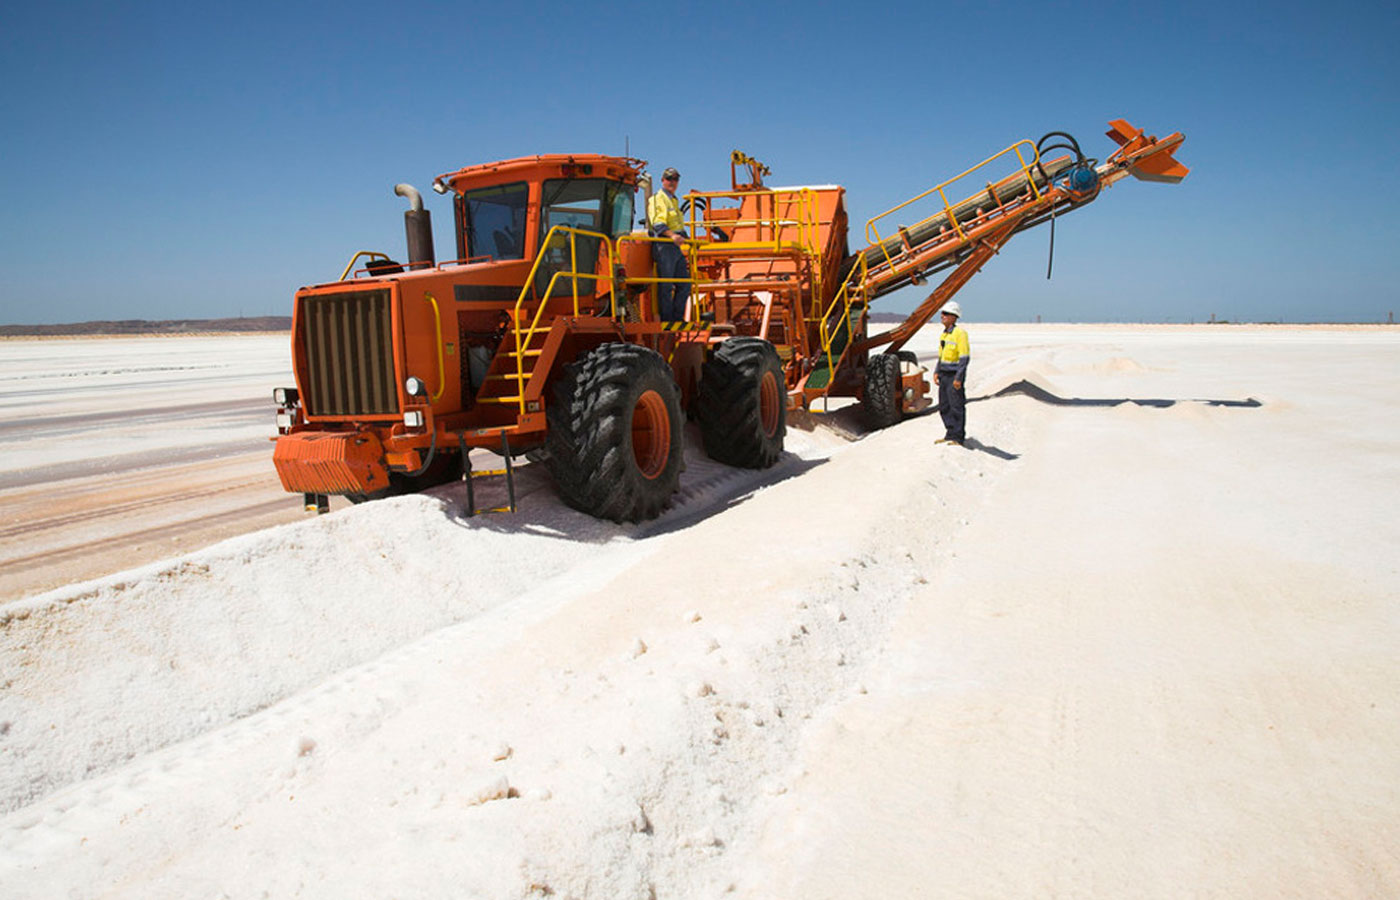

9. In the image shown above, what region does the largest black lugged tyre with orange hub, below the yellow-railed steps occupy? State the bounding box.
[546,343,685,522]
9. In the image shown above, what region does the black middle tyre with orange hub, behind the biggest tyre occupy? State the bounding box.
[696,337,787,469]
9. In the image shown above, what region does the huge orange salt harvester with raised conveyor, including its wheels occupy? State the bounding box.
[273,120,1187,521]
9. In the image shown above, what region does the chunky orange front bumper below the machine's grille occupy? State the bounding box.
[272,431,389,494]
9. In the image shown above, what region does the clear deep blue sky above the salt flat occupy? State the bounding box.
[0,0,1400,323]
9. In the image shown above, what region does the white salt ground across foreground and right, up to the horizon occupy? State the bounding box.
[0,322,1400,899]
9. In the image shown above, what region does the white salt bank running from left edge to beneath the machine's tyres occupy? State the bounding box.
[0,427,847,812]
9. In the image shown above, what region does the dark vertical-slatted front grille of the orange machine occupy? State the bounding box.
[301,288,399,416]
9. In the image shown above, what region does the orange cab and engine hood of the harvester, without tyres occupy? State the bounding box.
[274,154,655,495]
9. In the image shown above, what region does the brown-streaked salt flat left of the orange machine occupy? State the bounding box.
[0,335,306,602]
